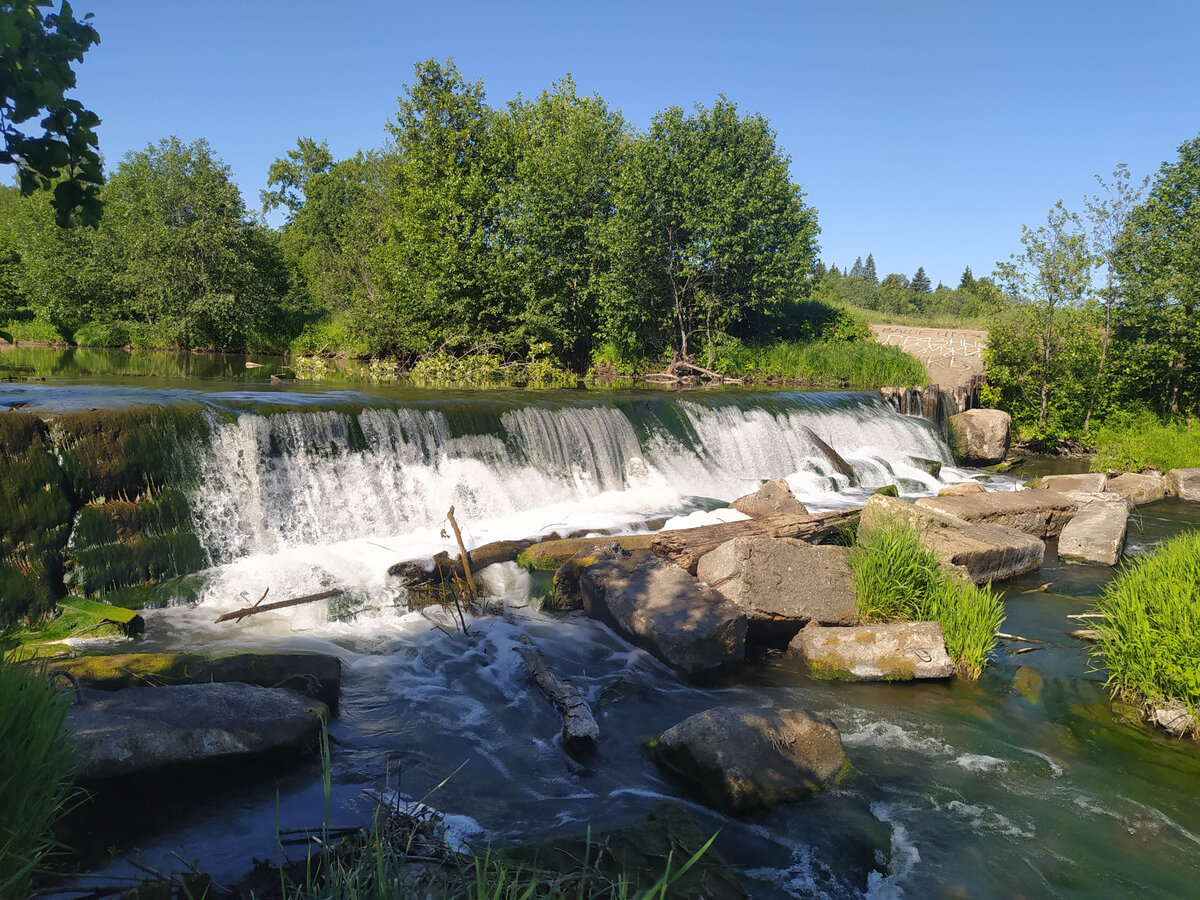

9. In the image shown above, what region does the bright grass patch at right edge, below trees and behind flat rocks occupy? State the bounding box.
[1092,413,1200,472]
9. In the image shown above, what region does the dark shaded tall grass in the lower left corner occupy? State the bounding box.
[0,658,74,898]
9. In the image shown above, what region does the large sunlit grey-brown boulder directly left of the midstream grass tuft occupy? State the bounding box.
[696,538,857,646]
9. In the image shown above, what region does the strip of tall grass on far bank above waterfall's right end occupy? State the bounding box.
[701,341,929,389]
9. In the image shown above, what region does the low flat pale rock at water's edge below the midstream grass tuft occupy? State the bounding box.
[787,622,954,682]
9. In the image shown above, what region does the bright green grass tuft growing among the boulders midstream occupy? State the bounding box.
[850,523,1004,678]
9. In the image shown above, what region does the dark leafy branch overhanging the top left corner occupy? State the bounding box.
[0,0,103,226]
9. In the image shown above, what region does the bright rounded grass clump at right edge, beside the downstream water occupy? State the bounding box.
[1096,532,1200,715]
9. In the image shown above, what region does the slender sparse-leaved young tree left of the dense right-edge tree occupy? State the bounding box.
[989,200,1092,434]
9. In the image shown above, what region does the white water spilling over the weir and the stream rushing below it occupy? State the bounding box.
[9,350,1200,898]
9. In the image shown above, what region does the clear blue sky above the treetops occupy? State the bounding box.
[60,0,1200,284]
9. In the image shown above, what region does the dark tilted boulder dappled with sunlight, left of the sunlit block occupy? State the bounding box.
[580,547,746,678]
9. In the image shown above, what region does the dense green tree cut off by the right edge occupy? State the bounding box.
[1114,136,1200,414]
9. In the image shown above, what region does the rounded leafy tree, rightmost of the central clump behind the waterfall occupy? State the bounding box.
[606,97,817,360]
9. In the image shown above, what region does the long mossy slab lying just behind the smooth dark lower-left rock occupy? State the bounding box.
[48,653,342,713]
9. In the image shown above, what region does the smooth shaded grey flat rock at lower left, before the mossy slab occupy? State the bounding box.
[67,683,328,781]
